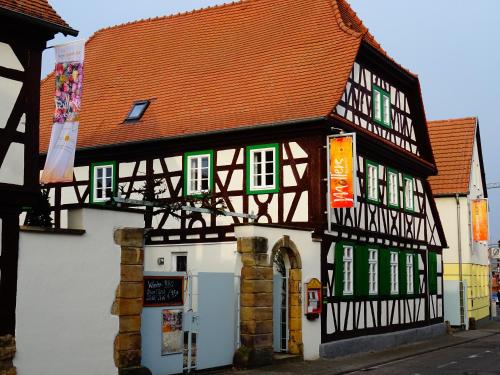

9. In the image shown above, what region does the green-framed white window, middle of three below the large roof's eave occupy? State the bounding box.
[183,150,214,197]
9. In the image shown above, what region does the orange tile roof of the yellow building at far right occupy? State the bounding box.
[428,117,477,195]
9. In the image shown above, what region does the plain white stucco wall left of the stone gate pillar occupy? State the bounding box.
[14,209,143,375]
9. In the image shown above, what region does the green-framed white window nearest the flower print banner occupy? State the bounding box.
[90,161,117,204]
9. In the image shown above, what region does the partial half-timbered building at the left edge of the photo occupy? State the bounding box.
[0,0,77,372]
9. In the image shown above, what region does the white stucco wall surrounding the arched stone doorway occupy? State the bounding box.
[235,226,321,360]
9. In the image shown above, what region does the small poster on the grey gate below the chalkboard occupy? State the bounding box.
[161,309,184,355]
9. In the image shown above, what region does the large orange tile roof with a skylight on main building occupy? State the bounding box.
[40,0,410,152]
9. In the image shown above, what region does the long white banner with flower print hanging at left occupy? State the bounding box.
[40,41,85,184]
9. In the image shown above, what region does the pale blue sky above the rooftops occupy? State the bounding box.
[42,0,500,243]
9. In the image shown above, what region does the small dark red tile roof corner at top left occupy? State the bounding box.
[0,0,74,31]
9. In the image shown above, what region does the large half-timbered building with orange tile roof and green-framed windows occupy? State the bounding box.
[40,0,446,364]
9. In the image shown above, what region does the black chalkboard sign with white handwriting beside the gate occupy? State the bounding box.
[144,276,184,306]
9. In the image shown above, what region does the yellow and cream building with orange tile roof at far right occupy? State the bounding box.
[428,117,490,327]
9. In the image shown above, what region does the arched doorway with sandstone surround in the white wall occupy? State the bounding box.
[270,236,303,354]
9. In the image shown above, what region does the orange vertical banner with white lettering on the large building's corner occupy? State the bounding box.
[329,134,355,208]
